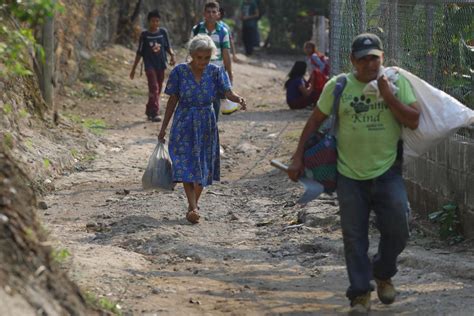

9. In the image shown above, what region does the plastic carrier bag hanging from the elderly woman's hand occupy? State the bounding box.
[142,142,175,190]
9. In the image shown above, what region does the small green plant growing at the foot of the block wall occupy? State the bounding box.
[428,203,464,244]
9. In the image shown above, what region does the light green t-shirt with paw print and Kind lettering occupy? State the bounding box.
[318,73,416,180]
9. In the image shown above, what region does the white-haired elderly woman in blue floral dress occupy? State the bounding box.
[158,35,246,224]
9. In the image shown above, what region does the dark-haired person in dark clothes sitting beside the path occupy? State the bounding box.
[285,61,319,110]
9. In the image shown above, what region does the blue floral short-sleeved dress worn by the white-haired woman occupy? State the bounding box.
[165,64,231,186]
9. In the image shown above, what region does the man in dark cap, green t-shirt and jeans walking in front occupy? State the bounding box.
[288,33,420,313]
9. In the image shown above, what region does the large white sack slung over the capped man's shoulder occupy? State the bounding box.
[364,67,474,163]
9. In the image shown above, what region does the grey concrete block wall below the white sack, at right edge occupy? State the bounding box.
[404,135,474,238]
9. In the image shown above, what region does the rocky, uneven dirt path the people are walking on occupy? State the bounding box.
[42,47,474,315]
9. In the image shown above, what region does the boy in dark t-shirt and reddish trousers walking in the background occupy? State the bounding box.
[130,10,175,122]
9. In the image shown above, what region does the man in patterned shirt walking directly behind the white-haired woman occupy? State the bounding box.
[191,1,234,120]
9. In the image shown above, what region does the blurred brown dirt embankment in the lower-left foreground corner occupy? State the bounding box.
[0,151,96,315]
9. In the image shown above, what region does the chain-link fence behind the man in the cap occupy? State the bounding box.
[330,0,474,139]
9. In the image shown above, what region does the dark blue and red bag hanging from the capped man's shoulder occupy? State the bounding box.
[303,75,347,193]
